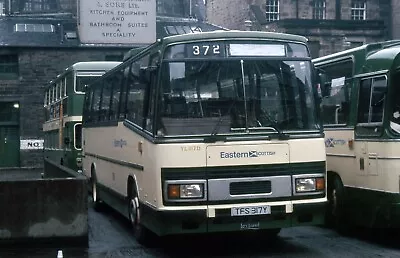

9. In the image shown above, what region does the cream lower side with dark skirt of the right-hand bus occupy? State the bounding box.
[325,129,400,227]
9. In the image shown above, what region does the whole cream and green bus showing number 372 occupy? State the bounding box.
[83,31,327,244]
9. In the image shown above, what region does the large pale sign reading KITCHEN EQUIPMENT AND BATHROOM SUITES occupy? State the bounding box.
[78,0,156,44]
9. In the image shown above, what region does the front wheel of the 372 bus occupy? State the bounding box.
[128,186,151,246]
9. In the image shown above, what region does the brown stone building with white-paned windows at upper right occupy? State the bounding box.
[206,0,400,57]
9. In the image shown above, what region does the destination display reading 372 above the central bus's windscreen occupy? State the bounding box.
[164,41,309,59]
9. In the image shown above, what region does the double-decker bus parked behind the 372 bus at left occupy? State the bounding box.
[43,61,121,171]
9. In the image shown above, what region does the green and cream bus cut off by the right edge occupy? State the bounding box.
[313,41,400,228]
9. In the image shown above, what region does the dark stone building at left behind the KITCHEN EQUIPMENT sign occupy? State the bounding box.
[0,0,217,168]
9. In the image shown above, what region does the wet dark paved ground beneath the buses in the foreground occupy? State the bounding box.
[0,202,400,258]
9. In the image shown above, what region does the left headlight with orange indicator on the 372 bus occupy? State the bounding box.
[165,180,206,201]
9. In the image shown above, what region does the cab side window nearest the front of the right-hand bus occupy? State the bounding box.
[356,76,387,135]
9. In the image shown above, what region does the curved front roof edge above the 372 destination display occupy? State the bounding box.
[162,30,307,44]
